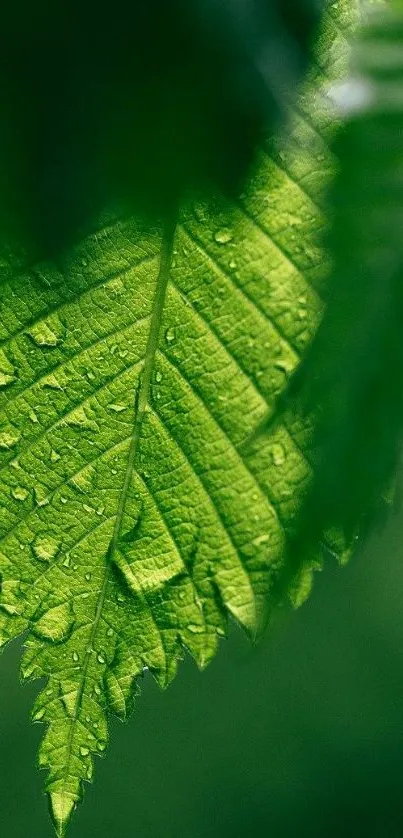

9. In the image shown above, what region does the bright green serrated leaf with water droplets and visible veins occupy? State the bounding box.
[0,2,351,835]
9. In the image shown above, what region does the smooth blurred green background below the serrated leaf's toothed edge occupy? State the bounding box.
[0,506,403,838]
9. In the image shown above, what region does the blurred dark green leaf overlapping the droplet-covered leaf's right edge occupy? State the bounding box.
[272,3,403,549]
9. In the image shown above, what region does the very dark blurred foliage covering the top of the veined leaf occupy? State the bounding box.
[0,0,323,258]
